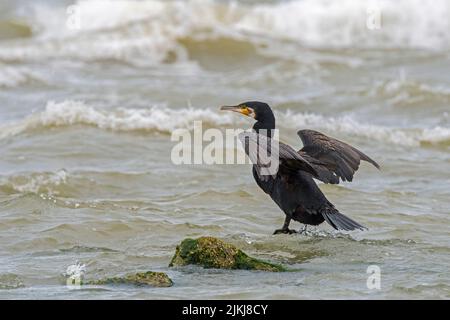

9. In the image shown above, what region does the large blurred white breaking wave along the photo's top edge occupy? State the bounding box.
[0,0,450,63]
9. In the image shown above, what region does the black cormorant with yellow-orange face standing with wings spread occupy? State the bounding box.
[221,101,380,234]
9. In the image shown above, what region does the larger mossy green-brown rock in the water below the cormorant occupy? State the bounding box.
[169,237,286,272]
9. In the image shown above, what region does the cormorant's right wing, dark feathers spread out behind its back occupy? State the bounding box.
[297,130,380,184]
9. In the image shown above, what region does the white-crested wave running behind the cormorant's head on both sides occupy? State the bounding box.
[0,100,450,146]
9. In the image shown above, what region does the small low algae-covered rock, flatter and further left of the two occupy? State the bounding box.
[86,271,173,287]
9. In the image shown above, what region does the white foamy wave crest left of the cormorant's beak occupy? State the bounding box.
[0,100,237,138]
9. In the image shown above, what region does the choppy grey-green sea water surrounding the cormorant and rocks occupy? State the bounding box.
[0,0,450,299]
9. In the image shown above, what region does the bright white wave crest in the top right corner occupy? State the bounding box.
[238,0,450,49]
